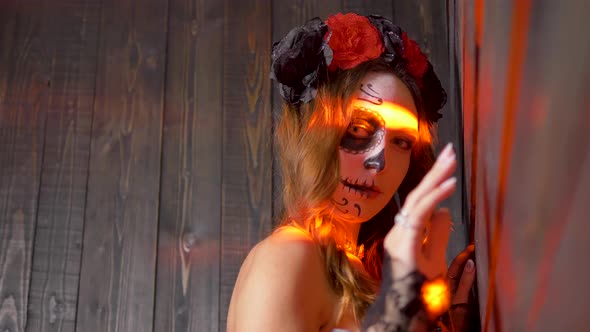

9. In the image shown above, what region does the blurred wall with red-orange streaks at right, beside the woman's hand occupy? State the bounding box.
[460,0,590,331]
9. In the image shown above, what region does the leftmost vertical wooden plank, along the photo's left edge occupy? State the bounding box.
[0,1,50,331]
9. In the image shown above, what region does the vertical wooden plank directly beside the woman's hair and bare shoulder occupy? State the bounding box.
[219,0,272,331]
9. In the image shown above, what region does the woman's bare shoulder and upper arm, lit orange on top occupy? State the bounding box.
[228,226,331,331]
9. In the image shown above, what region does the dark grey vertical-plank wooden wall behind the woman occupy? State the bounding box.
[0,0,467,332]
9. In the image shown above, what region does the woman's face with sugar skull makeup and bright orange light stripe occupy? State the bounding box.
[331,73,418,222]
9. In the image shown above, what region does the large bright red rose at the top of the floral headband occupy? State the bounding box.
[326,13,383,70]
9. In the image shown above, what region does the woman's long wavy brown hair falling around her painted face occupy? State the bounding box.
[276,59,435,321]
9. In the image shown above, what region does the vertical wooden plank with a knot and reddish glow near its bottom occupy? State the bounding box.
[155,0,223,331]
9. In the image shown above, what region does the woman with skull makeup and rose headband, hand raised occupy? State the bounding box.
[227,14,473,332]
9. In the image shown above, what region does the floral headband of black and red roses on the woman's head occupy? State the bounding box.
[271,13,447,123]
